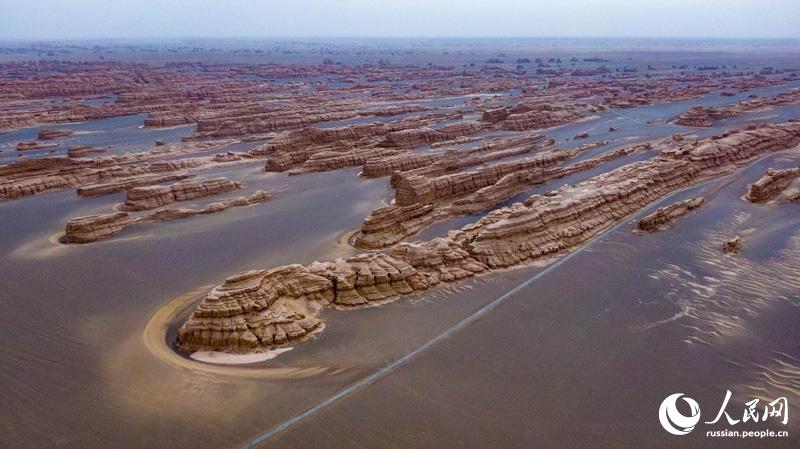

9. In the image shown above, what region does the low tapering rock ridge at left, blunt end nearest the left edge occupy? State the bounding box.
[65,190,272,244]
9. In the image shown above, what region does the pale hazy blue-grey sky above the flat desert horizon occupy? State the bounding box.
[0,0,800,39]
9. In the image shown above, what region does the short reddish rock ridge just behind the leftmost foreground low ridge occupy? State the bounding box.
[124,178,242,211]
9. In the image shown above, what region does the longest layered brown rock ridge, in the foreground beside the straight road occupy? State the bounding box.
[177,122,800,352]
